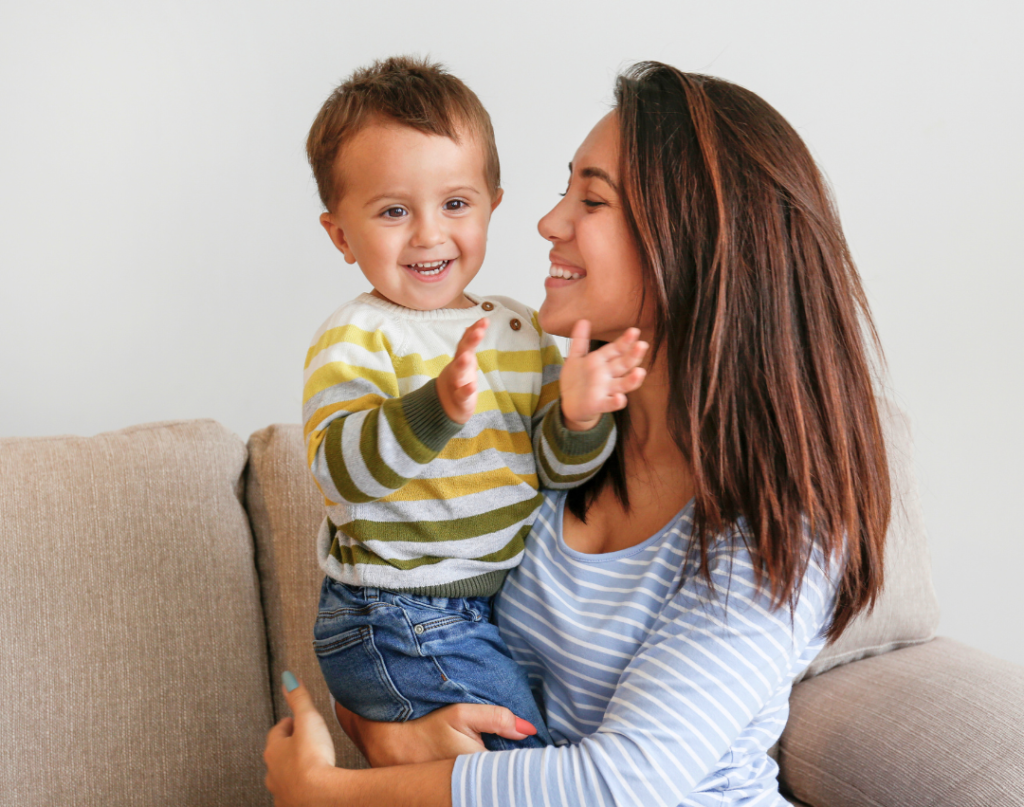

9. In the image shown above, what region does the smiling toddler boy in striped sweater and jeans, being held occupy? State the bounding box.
[303,58,646,749]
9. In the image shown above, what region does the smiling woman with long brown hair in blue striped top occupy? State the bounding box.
[264,62,890,807]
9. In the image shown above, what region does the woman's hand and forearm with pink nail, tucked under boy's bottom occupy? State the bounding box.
[335,704,537,768]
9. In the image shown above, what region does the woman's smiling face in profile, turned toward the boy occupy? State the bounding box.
[538,112,653,342]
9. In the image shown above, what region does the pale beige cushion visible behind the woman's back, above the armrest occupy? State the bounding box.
[805,398,939,678]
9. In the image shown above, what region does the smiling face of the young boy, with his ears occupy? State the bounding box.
[321,123,501,310]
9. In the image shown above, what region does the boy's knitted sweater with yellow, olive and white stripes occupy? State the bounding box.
[302,294,614,597]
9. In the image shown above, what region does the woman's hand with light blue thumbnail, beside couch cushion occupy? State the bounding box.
[263,673,335,807]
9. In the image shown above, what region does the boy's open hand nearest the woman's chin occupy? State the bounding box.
[559,320,647,431]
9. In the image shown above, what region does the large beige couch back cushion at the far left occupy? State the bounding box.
[0,421,271,807]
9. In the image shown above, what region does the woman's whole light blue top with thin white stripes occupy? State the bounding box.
[452,492,836,807]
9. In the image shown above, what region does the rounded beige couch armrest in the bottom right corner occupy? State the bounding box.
[779,638,1024,807]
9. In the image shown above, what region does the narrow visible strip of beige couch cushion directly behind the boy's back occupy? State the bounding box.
[246,425,367,768]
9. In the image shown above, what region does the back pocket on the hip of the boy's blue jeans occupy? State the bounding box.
[313,625,413,722]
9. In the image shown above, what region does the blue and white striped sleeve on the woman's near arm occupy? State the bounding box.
[452,537,833,807]
